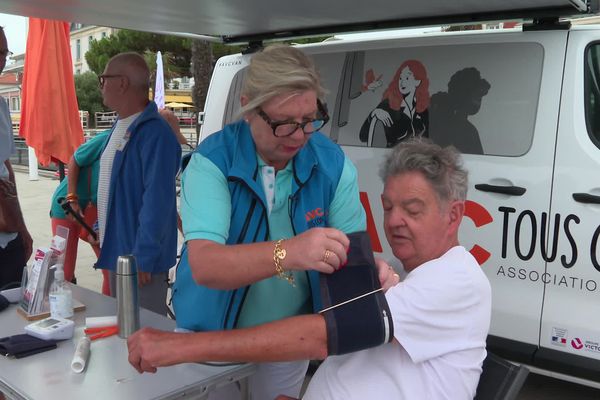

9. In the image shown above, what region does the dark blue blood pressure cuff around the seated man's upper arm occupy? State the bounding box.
[319,232,394,355]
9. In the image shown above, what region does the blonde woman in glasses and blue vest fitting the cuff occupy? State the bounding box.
[173,45,366,400]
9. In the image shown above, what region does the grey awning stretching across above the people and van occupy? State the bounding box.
[0,0,599,42]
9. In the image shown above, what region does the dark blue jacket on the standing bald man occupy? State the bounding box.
[96,102,181,273]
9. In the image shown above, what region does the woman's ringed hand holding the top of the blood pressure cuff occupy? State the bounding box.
[281,228,350,274]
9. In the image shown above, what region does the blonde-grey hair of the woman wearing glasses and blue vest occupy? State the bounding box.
[240,44,325,114]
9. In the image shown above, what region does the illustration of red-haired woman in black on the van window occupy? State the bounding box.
[359,60,430,147]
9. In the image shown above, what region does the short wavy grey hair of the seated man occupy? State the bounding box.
[379,138,469,203]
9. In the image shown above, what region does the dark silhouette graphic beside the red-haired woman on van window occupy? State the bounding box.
[429,67,491,154]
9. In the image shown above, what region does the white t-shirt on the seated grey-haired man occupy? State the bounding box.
[303,246,491,400]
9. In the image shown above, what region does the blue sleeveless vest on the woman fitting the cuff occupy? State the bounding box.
[173,121,345,331]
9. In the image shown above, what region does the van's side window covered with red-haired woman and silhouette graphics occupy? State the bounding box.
[314,43,543,156]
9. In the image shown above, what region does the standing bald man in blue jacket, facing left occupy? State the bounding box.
[97,53,181,314]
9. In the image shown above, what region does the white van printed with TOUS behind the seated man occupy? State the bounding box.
[202,24,600,385]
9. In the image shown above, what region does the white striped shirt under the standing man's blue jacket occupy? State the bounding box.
[97,112,141,247]
